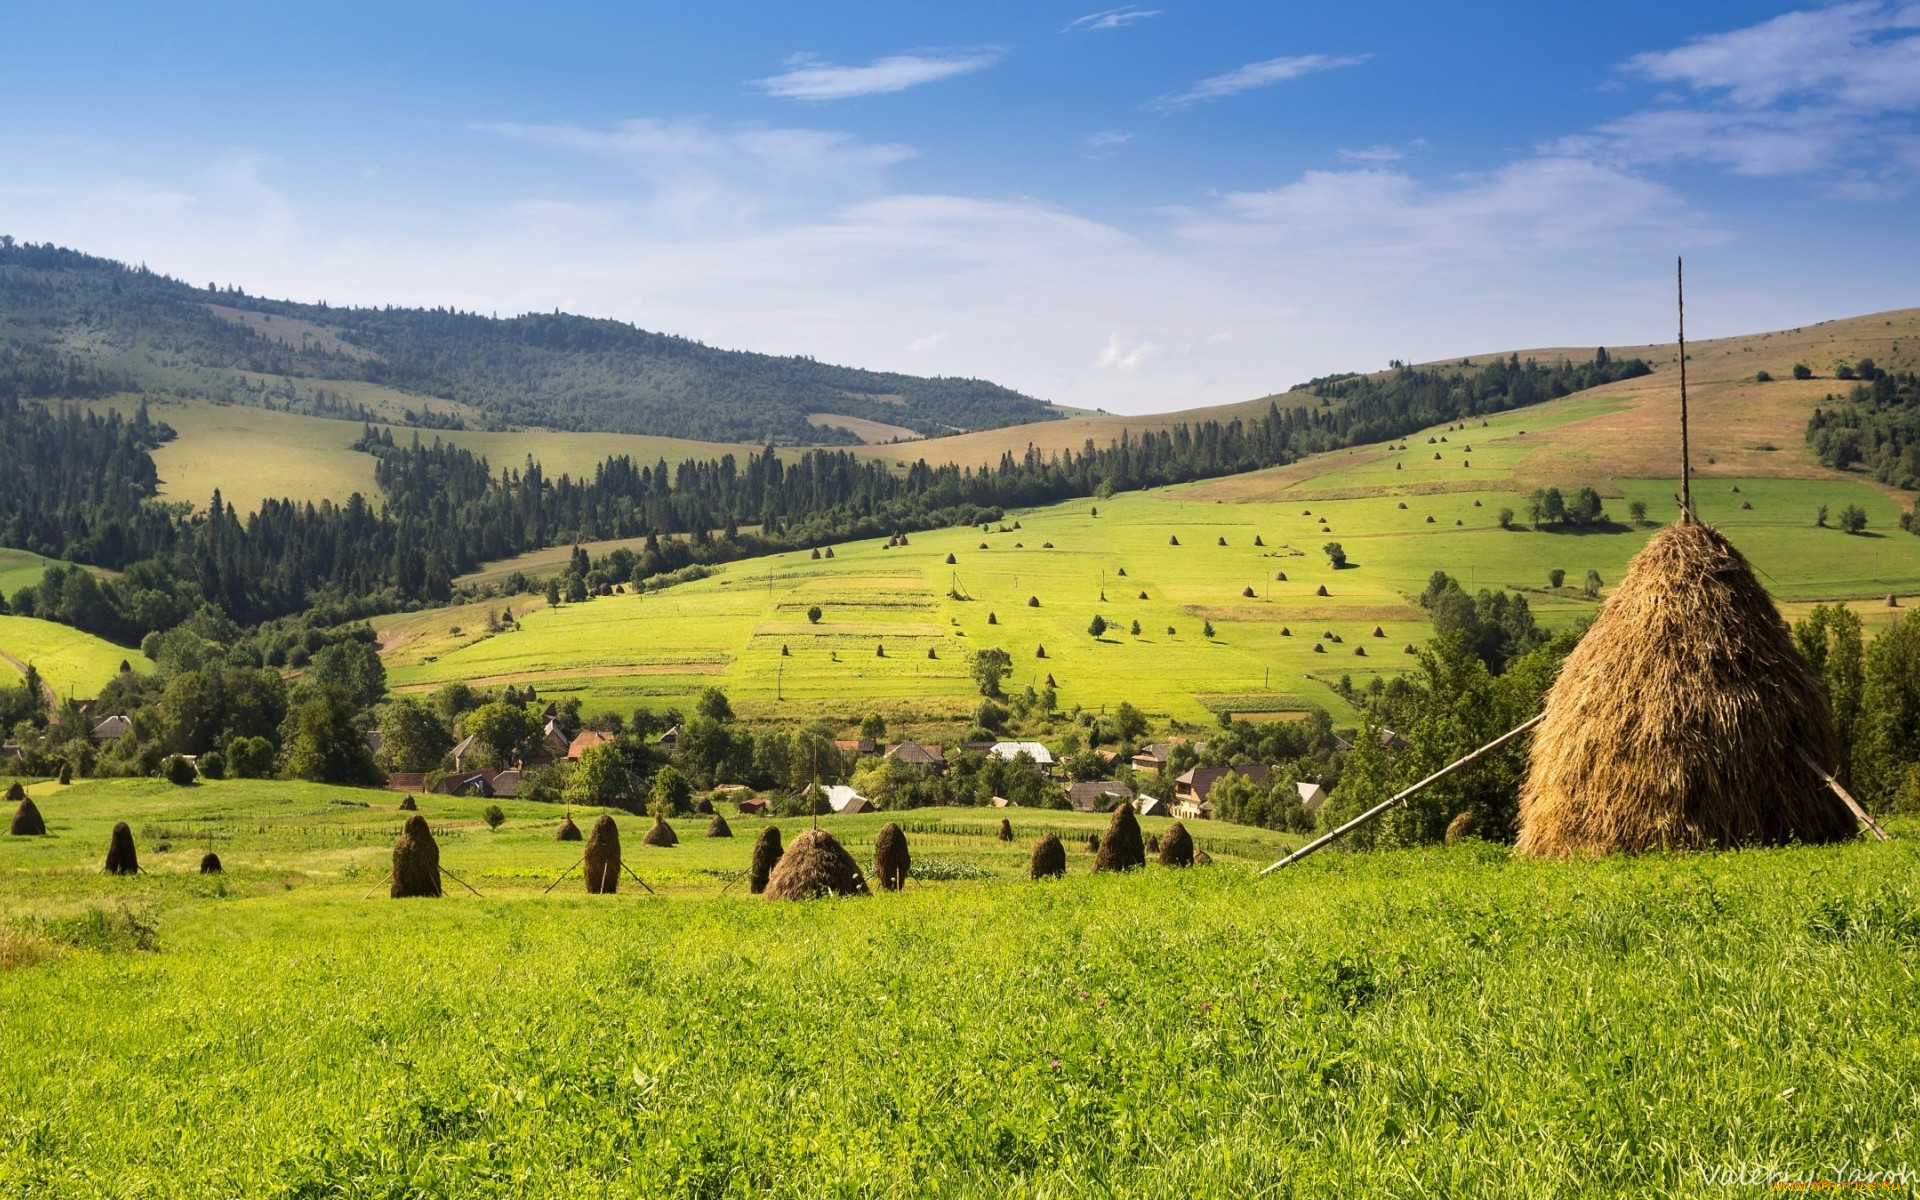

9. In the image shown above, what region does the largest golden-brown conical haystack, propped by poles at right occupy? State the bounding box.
[1517,522,1855,858]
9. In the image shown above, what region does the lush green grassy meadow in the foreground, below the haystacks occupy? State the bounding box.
[0,781,1920,1198]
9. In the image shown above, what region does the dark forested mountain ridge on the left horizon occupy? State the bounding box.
[0,238,1054,444]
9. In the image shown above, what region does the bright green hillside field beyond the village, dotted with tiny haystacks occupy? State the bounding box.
[393,396,1920,728]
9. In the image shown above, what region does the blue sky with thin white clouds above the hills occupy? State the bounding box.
[0,0,1920,411]
